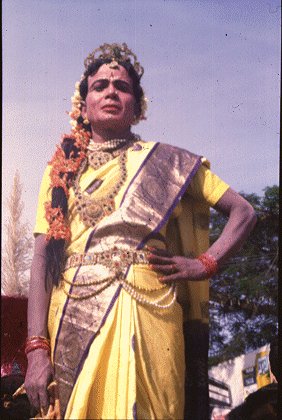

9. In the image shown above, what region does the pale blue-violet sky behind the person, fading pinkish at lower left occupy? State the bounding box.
[2,0,281,235]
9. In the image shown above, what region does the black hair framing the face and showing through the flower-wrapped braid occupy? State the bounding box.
[45,59,144,286]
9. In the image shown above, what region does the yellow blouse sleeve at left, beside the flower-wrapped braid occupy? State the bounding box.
[33,166,51,235]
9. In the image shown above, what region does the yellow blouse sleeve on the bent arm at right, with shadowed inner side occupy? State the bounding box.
[187,164,229,207]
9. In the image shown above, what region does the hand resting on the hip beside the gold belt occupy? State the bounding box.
[148,248,207,283]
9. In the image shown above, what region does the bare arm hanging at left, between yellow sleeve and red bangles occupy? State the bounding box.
[28,235,52,337]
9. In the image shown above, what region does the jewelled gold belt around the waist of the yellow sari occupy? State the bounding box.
[64,247,150,272]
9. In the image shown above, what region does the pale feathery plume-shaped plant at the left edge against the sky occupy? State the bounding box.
[1,172,32,296]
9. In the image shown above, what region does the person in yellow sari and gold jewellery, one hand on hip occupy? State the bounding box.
[25,44,255,419]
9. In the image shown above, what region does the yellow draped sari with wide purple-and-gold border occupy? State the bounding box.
[35,141,228,419]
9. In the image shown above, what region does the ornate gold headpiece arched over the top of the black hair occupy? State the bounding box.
[84,42,144,79]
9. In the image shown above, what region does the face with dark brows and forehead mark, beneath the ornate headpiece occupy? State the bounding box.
[82,64,136,131]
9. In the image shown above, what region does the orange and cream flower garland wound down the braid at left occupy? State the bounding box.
[45,82,91,241]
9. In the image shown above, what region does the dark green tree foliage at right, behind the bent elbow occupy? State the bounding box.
[210,185,279,365]
